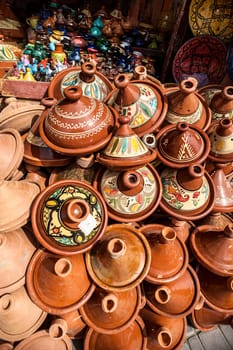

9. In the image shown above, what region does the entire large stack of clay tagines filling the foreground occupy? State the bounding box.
[0,69,233,350]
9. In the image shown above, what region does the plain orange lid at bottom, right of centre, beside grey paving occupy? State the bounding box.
[140,308,187,350]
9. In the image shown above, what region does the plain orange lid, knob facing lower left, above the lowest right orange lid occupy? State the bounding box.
[143,265,200,318]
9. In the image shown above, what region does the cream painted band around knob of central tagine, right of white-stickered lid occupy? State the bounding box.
[101,167,158,214]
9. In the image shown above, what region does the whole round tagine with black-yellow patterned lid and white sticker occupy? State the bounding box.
[31,180,108,255]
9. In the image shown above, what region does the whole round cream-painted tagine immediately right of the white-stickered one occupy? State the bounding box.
[93,164,162,222]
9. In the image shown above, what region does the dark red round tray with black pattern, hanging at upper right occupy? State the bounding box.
[172,35,227,87]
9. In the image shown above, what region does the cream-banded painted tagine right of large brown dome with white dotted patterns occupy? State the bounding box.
[105,74,167,137]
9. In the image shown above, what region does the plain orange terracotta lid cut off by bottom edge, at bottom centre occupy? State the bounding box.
[83,317,147,350]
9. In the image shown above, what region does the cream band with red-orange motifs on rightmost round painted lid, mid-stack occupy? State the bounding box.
[160,168,210,211]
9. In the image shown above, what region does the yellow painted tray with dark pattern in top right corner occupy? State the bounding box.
[189,0,233,42]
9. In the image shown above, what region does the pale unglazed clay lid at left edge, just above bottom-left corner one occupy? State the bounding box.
[0,286,47,342]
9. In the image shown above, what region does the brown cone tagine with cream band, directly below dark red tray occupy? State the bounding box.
[165,77,211,131]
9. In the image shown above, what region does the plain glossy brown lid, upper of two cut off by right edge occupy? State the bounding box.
[190,224,233,276]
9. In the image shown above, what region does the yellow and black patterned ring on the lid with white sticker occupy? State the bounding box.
[41,185,104,246]
